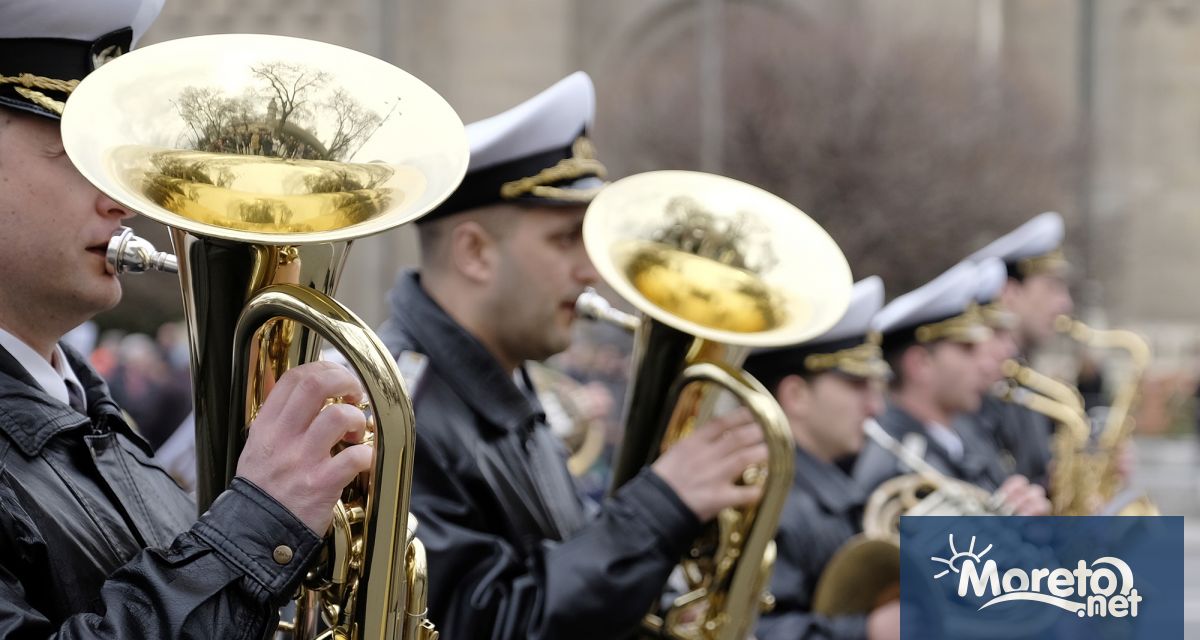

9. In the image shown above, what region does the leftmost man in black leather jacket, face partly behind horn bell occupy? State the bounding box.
[0,0,372,640]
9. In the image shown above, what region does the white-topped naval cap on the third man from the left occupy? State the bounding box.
[744,275,890,385]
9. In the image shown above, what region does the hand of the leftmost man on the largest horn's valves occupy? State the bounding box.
[238,361,374,534]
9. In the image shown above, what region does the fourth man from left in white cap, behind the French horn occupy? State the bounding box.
[854,263,1050,515]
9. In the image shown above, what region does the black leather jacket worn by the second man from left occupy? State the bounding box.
[380,273,700,640]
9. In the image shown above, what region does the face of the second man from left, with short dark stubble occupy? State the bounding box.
[492,204,599,360]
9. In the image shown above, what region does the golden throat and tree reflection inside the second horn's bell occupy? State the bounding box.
[625,196,787,333]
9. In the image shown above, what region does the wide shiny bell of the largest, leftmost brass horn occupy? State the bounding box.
[62,35,468,245]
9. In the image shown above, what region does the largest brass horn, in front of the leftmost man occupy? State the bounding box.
[62,35,467,640]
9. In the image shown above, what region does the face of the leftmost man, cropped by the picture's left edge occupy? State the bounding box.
[0,108,130,319]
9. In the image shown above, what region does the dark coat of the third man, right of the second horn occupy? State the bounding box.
[755,449,866,640]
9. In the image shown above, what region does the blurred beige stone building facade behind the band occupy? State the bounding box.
[131,0,1200,367]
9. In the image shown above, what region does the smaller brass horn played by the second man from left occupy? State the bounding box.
[576,171,851,640]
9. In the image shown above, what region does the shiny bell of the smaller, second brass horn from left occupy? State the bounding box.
[583,171,852,347]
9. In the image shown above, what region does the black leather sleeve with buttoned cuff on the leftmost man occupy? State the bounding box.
[0,478,320,640]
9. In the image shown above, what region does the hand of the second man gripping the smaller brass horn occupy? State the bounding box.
[652,408,767,522]
